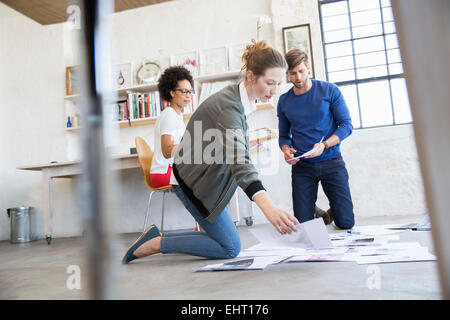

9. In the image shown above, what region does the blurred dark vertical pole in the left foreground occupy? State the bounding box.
[80,0,118,299]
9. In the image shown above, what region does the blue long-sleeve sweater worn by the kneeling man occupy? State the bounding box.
[277,79,353,162]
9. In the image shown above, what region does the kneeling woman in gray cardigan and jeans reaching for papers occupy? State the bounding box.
[123,41,298,263]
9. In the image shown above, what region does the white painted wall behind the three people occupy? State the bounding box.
[0,0,426,239]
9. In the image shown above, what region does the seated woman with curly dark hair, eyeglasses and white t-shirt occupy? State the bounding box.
[150,66,194,188]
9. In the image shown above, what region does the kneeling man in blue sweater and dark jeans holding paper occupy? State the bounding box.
[278,49,355,229]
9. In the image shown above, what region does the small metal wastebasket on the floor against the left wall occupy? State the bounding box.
[6,206,36,243]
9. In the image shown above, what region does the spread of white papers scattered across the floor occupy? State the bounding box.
[196,219,436,272]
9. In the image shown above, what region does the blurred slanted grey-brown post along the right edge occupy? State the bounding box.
[392,0,450,299]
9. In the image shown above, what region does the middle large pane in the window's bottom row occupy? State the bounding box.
[358,81,393,127]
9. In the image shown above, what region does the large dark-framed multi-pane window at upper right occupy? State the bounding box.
[319,0,412,129]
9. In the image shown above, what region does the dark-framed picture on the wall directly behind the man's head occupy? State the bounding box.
[282,23,315,78]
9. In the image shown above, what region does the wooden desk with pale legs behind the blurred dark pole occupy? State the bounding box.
[17,154,140,244]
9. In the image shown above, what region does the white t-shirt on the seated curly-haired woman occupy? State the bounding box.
[150,107,186,174]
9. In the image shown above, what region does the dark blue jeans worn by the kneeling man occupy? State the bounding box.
[292,155,355,229]
